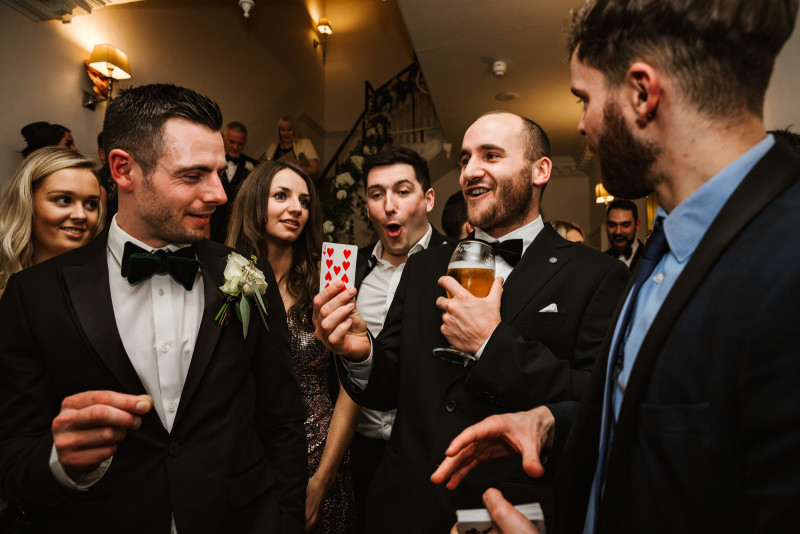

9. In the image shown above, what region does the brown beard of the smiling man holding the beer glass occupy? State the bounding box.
[467,166,534,232]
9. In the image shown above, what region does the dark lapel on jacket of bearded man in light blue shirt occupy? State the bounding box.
[603,145,800,528]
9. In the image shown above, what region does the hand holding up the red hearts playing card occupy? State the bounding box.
[312,282,370,361]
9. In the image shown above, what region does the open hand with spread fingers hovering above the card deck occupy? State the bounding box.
[431,406,555,489]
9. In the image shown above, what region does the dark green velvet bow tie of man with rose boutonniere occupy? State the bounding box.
[122,241,200,291]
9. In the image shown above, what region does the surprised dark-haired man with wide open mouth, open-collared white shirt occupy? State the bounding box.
[350,146,444,532]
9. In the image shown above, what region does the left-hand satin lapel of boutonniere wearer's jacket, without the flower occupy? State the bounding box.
[61,232,148,398]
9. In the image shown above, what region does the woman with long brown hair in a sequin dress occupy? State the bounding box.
[227,161,358,534]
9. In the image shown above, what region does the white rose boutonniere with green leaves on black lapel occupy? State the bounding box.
[214,252,269,337]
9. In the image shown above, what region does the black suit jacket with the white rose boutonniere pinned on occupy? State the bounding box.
[0,234,306,534]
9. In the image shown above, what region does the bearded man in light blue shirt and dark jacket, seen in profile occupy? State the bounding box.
[435,0,800,534]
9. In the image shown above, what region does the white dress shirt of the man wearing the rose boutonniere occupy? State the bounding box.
[50,215,205,532]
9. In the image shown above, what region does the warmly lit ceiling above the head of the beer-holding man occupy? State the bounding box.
[397,0,585,168]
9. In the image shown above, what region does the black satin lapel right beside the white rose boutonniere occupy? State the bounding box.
[173,241,225,428]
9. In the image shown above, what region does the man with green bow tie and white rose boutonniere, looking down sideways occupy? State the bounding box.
[0,85,306,534]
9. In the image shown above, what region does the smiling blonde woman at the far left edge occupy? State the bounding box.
[0,146,102,294]
